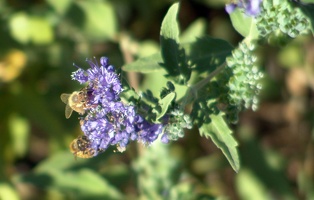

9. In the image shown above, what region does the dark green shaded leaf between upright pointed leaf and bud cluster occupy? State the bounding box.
[185,36,233,73]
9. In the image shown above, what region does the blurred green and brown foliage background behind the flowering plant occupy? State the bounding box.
[0,0,314,200]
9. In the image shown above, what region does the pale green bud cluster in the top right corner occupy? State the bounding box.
[257,0,310,38]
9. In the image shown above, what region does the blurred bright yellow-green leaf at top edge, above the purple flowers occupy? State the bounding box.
[75,0,117,41]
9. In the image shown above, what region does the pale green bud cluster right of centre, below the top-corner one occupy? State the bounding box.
[224,43,263,123]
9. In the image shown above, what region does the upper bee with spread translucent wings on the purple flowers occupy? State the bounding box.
[60,88,87,119]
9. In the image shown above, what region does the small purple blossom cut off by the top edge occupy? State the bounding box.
[225,0,262,16]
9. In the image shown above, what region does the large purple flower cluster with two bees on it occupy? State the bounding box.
[72,57,162,155]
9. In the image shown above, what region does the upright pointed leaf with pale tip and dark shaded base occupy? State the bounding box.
[160,3,191,84]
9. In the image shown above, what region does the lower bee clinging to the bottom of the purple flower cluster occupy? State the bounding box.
[70,135,96,159]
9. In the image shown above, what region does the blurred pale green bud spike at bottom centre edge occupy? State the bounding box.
[132,140,182,200]
